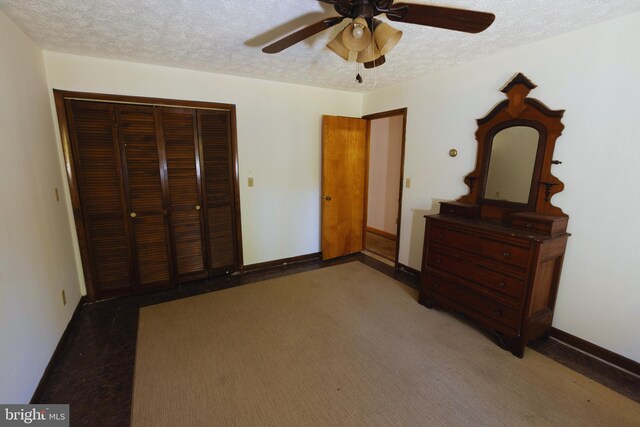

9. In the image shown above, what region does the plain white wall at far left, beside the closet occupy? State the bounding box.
[0,12,80,403]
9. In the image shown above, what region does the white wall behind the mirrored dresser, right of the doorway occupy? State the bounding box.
[364,13,640,361]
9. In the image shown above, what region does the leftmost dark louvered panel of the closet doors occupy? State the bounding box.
[66,100,133,296]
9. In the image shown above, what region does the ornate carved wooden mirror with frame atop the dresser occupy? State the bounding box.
[458,73,564,220]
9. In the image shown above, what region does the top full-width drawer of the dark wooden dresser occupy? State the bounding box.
[428,225,530,270]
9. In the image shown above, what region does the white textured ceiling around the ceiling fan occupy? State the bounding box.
[0,0,640,91]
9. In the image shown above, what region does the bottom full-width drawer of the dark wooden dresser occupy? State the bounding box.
[425,274,520,332]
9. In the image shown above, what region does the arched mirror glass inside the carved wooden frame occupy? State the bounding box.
[484,126,540,203]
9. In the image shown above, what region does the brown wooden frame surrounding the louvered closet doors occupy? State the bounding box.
[53,89,244,302]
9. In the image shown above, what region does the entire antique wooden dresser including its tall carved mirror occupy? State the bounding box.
[420,74,569,357]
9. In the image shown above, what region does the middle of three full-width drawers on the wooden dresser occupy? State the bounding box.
[427,245,524,305]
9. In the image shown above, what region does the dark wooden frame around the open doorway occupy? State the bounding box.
[362,107,408,268]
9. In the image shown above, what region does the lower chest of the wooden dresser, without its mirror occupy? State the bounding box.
[420,203,569,357]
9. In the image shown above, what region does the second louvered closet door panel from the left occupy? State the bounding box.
[116,105,172,287]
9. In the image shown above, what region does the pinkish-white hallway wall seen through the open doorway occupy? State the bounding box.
[367,116,404,236]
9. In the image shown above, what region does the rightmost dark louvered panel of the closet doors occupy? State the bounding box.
[198,110,238,274]
